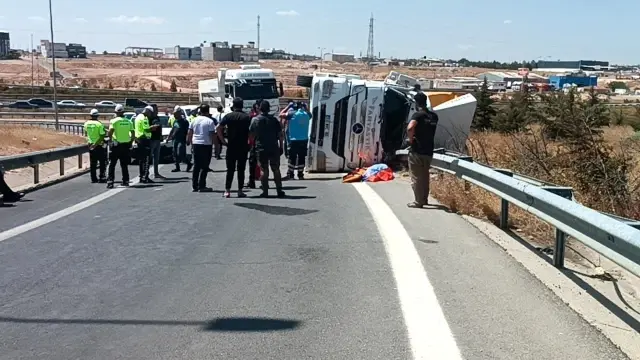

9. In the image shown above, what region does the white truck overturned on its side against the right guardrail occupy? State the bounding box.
[297,72,476,172]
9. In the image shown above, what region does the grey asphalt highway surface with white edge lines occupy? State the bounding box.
[0,160,626,360]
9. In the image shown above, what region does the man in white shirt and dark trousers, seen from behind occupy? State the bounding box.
[187,104,216,192]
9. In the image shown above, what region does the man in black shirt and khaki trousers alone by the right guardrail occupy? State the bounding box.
[407,92,438,208]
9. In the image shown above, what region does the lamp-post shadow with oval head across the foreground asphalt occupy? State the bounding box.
[0,317,302,332]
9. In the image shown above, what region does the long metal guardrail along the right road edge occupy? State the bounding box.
[396,149,640,276]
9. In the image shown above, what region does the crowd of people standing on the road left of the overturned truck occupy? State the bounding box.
[84,98,311,197]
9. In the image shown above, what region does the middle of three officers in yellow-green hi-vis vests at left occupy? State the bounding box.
[107,104,135,189]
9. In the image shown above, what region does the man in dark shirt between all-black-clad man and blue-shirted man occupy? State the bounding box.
[249,101,285,197]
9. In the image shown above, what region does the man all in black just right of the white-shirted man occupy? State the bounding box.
[217,97,251,198]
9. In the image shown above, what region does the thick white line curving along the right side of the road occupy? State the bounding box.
[353,183,462,360]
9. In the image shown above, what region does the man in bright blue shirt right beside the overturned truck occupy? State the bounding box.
[287,102,311,180]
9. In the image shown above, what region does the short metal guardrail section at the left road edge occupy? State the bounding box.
[0,145,89,184]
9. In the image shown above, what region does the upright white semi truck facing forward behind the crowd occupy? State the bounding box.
[198,64,282,114]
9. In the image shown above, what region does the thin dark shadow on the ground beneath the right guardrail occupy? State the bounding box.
[504,230,640,333]
